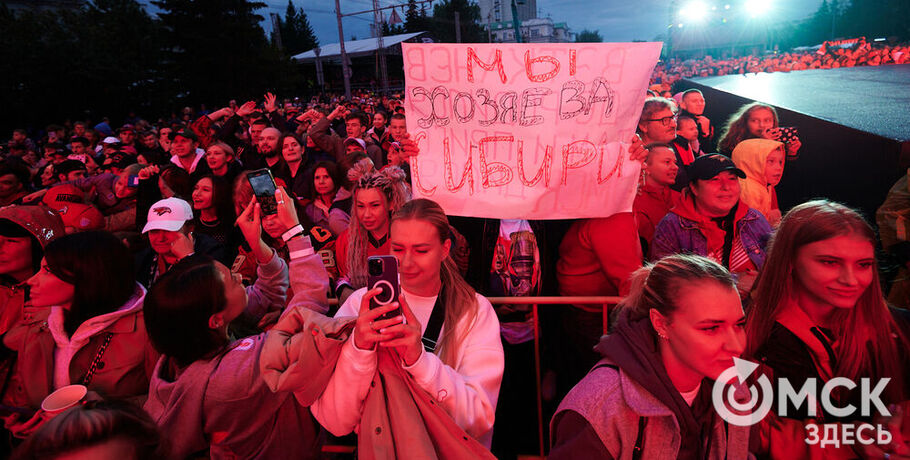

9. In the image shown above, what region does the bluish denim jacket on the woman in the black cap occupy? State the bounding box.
[650,208,771,269]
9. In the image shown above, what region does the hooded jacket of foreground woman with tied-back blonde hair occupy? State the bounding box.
[550,310,749,460]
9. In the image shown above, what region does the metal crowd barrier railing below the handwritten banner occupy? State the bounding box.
[323,296,622,458]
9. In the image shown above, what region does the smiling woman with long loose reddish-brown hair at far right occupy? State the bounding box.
[746,200,910,458]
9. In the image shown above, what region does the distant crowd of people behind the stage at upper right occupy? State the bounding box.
[651,38,910,97]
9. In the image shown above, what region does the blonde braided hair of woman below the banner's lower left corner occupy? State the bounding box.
[347,161,411,289]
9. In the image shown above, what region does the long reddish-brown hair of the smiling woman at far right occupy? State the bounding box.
[746,200,907,402]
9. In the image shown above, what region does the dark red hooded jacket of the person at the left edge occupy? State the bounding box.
[0,206,66,335]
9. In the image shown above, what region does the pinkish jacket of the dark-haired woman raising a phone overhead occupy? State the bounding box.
[145,237,328,459]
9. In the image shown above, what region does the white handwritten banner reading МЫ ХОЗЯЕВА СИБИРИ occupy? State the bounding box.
[402,43,661,219]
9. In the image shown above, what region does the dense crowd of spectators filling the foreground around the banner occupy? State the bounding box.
[0,55,910,459]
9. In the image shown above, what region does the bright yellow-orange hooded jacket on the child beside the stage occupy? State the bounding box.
[733,139,784,225]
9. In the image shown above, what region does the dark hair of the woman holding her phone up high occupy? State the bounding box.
[143,254,230,367]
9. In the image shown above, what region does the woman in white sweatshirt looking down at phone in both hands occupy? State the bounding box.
[311,199,504,448]
